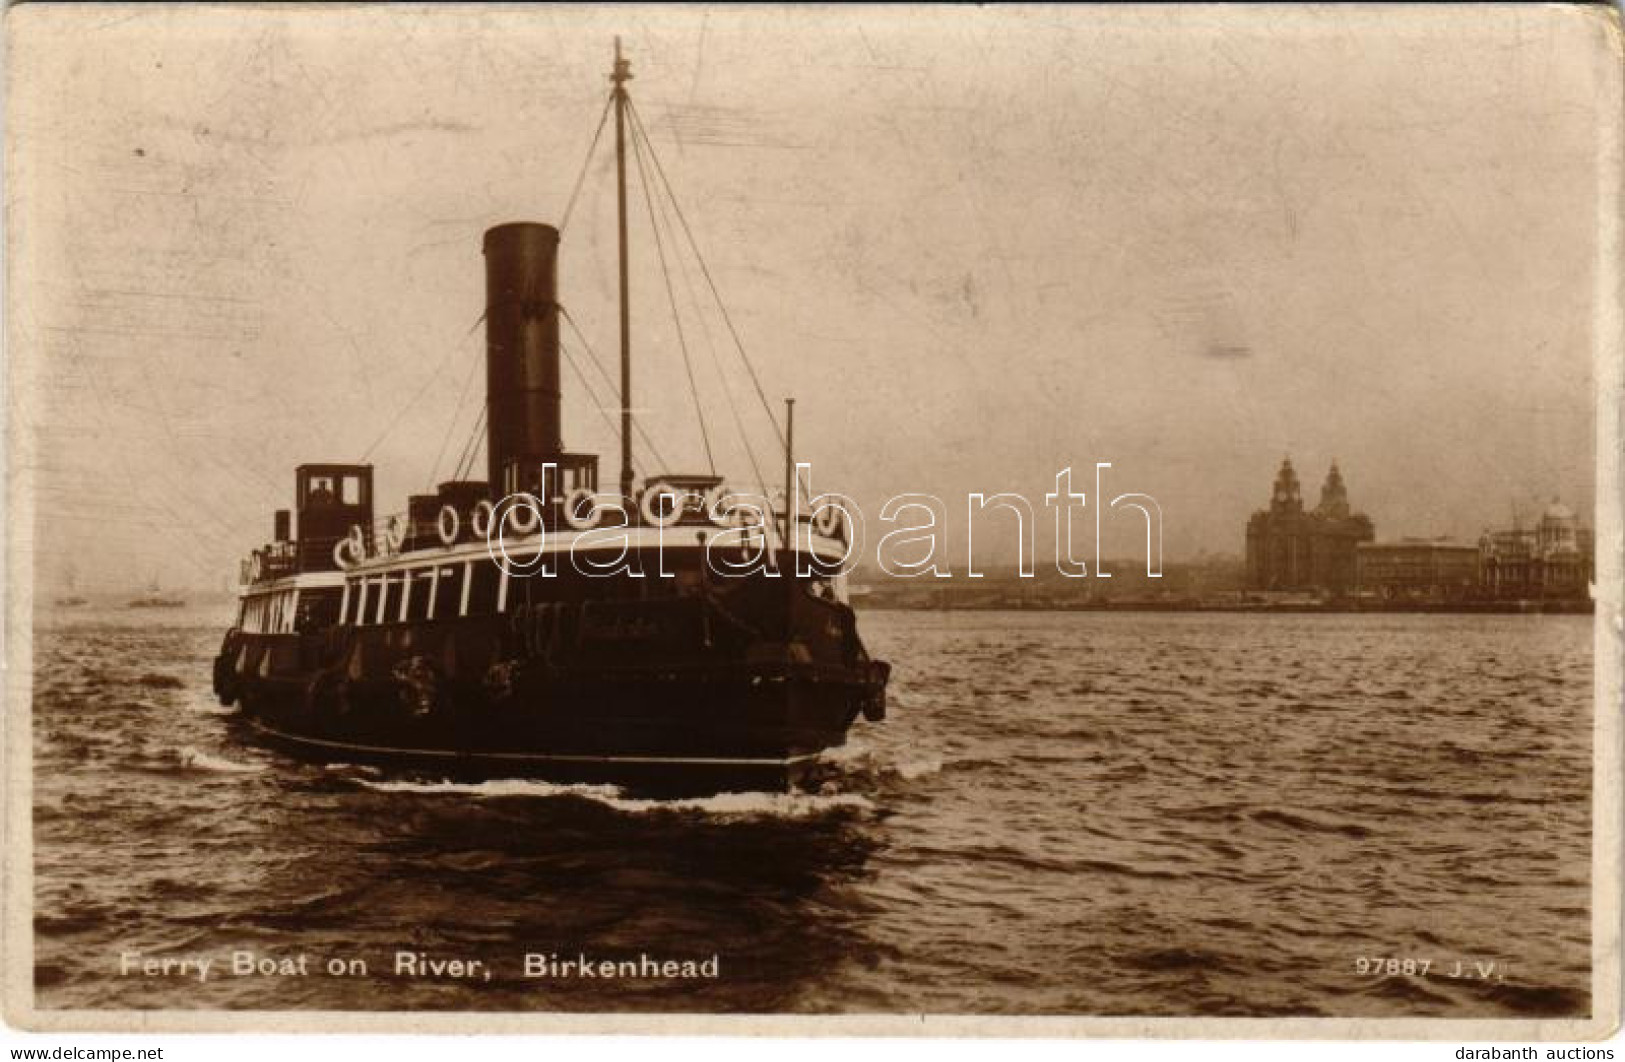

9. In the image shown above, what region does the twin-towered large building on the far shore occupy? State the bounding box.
[1246,458,1375,598]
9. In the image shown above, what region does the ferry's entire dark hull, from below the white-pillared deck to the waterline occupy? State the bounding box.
[215,555,891,792]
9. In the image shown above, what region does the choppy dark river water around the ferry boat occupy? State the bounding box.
[34,609,1593,1017]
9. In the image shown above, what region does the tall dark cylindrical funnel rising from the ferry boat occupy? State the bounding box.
[484,221,564,497]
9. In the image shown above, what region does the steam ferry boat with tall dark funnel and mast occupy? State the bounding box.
[213,41,889,792]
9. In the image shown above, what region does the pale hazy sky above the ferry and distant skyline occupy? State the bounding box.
[8,5,1619,586]
